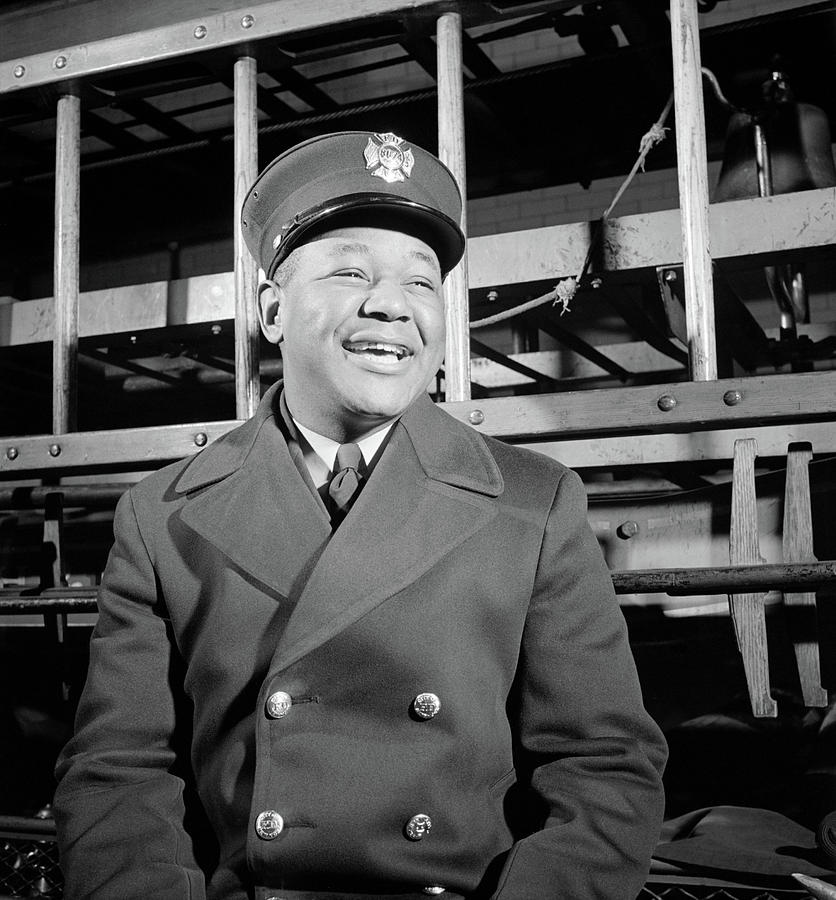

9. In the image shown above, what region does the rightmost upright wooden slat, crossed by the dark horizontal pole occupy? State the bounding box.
[783,443,828,706]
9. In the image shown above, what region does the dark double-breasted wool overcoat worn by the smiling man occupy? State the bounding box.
[55,388,664,900]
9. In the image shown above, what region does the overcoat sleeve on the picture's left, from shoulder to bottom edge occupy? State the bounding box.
[54,493,205,900]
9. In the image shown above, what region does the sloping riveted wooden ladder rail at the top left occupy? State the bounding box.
[0,0,454,94]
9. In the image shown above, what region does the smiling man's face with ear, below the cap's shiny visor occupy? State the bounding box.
[260,226,445,441]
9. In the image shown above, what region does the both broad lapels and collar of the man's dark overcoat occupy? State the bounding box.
[176,386,503,667]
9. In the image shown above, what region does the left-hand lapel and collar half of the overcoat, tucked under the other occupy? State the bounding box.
[177,385,331,597]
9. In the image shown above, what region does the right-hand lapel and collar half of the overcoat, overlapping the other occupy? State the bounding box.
[274,396,502,670]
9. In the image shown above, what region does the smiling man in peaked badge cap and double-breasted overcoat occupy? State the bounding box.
[55,132,665,900]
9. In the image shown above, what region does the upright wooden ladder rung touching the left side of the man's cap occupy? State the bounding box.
[232,56,261,419]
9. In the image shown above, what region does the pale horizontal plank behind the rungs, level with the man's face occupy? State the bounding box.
[0,188,836,347]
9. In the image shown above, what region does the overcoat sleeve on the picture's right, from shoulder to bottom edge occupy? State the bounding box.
[494,471,667,900]
